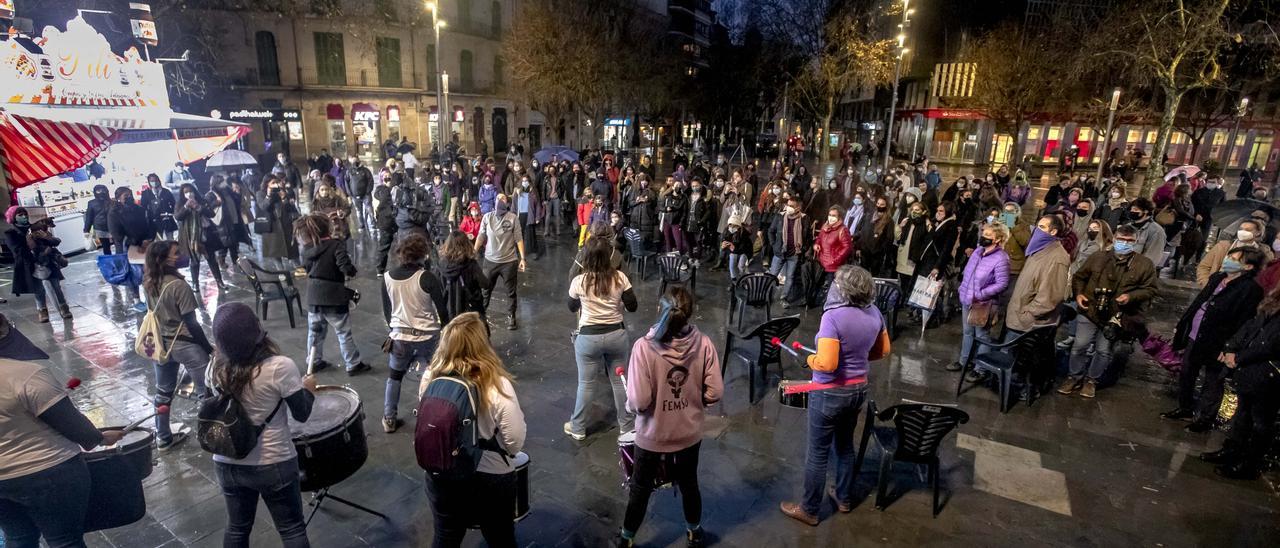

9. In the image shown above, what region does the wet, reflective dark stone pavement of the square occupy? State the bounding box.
[0,224,1280,547]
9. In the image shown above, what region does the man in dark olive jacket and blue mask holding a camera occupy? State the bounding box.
[1057,224,1157,398]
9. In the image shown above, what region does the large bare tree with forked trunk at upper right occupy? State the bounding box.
[1083,0,1240,196]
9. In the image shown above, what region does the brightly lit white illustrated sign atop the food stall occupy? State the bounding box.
[0,17,169,108]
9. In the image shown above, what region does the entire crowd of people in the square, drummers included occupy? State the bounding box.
[0,142,1280,547]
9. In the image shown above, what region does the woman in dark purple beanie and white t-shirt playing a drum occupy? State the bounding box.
[209,302,316,548]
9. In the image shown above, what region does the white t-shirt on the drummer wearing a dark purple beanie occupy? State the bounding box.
[209,356,303,466]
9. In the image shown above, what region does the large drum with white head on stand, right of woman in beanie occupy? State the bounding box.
[288,387,369,492]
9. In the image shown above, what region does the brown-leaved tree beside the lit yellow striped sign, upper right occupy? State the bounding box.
[957,23,1073,163]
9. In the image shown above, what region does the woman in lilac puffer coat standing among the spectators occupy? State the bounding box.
[947,222,1009,371]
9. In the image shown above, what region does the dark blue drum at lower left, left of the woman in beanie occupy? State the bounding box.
[84,426,155,533]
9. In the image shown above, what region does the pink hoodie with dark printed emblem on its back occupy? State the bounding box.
[627,325,724,453]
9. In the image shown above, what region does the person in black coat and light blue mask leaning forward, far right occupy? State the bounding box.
[1160,247,1266,433]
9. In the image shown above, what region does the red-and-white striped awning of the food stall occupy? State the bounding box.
[0,105,250,188]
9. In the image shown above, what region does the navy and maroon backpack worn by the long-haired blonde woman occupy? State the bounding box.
[413,375,506,479]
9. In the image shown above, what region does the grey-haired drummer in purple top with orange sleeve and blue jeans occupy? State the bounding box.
[780,265,888,525]
